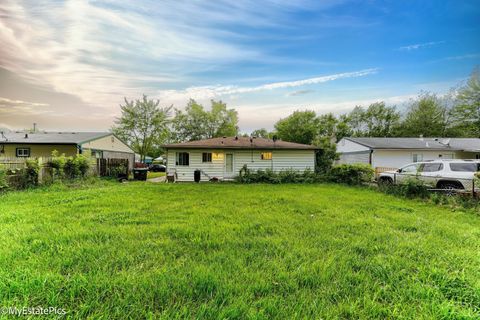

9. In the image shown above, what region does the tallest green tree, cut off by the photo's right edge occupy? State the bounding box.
[452,68,480,138]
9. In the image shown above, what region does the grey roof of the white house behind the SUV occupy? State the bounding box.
[345,138,480,152]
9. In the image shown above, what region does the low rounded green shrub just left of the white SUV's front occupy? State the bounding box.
[327,164,374,185]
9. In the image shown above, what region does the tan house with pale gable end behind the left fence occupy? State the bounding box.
[0,132,135,166]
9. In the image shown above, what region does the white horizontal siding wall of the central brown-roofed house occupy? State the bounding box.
[167,149,315,181]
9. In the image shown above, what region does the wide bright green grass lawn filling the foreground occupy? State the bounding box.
[0,182,480,319]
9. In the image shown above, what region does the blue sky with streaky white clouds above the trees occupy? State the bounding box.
[0,0,480,132]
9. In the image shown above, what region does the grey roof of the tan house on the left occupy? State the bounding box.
[0,131,111,144]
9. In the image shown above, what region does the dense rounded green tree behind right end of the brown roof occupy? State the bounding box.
[275,110,318,144]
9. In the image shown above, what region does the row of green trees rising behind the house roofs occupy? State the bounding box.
[112,69,480,162]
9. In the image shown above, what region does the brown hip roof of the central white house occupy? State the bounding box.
[164,137,318,150]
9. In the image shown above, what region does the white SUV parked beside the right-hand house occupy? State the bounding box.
[378,160,480,190]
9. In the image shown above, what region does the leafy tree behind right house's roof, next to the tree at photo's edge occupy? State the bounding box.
[400,93,448,137]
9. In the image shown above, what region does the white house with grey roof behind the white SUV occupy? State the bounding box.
[337,138,480,168]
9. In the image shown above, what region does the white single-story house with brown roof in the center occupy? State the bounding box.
[164,137,317,181]
